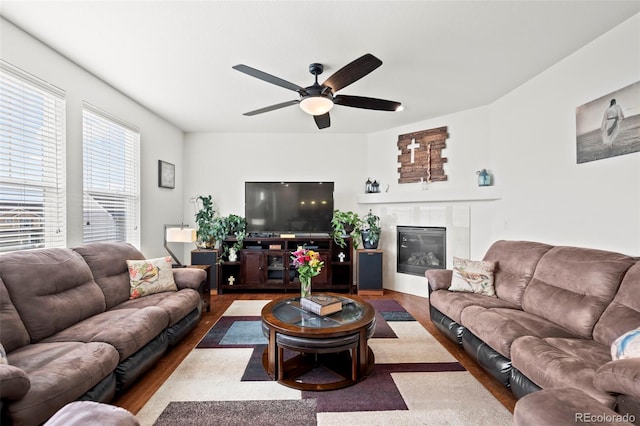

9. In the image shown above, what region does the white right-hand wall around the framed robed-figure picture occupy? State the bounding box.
[484,15,640,256]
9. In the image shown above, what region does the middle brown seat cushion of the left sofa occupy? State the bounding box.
[41,306,169,361]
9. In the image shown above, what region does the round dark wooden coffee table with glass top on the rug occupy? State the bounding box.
[262,293,376,391]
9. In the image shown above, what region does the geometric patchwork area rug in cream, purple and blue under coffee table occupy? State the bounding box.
[137,300,512,426]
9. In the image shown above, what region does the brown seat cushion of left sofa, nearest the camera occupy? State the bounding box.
[7,342,118,425]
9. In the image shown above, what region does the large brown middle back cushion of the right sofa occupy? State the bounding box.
[522,247,635,339]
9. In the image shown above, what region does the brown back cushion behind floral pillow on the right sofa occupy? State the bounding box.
[484,241,552,306]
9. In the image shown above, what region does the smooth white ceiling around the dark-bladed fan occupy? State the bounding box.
[0,0,640,133]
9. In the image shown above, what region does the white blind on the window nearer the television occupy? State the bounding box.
[82,103,140,247]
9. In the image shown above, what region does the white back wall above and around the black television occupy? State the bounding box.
[184,132,366,256]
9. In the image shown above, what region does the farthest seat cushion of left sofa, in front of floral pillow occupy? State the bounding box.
[113,288,201,327]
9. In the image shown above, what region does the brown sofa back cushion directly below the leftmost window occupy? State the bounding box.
[0,248,105,343]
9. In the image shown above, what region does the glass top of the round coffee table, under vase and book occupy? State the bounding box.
[273,297,364,328]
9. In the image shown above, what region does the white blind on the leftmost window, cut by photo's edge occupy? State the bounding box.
[0,60,67,251]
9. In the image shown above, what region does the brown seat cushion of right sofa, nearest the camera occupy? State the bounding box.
[511,336,616,407]
